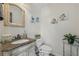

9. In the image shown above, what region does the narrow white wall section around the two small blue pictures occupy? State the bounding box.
[26,4,41,38]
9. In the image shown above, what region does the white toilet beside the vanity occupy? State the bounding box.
[36,39,52,56]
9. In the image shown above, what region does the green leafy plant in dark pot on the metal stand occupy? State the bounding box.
[63,33,79,44]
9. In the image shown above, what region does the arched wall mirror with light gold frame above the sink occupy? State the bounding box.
[3,3,25,27]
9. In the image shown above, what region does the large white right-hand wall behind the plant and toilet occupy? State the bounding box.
[29,4,79,55]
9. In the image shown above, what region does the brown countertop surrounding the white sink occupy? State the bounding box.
[0,38,36,52]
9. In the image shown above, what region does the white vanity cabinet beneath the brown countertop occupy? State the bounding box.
[3,42,35,56]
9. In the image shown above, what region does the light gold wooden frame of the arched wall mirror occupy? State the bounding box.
[3,3,25,27]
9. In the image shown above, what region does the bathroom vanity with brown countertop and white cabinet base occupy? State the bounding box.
[1,39,36,56]
